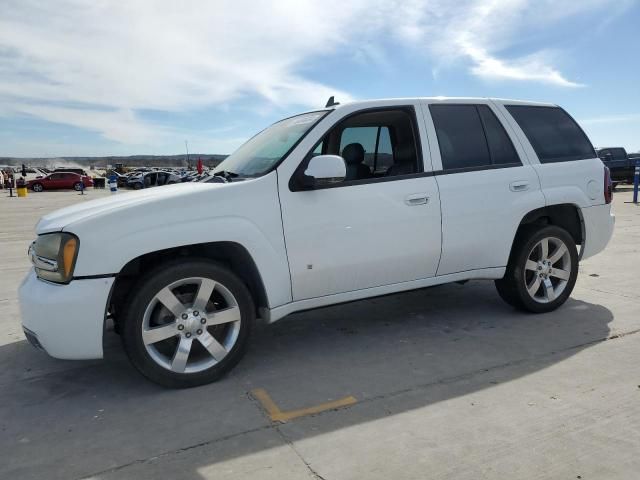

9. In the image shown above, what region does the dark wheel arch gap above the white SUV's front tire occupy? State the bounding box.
[108,241,269,324]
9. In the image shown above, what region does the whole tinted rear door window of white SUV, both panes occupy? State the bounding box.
[429,104,520,170]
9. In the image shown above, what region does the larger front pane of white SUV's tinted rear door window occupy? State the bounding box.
[429,105,491,170]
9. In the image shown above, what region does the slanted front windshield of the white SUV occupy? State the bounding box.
[214,110,329,177]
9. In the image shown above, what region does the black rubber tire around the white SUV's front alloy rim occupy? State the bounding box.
[121,258,255,388]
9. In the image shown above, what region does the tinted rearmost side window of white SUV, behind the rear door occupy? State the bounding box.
[505,105,596,163]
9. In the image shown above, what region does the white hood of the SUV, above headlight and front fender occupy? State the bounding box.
[36,183,228,235]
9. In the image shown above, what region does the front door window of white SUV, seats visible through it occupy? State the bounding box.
[300,107,421,186]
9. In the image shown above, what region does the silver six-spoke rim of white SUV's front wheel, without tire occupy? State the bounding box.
[142,277,241,373]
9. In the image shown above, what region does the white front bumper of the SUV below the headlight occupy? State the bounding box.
[18,269,114,360]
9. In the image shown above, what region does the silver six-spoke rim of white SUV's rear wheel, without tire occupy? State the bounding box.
[524,237,572,303]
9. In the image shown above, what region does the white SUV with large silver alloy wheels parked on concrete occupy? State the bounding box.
[20,98,614,387]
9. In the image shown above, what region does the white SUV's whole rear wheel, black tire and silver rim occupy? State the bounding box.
[495,225,578,313]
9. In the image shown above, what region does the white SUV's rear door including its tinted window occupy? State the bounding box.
[423,100,545,275]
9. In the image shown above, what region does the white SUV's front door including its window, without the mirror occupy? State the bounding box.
[278,104,441,301]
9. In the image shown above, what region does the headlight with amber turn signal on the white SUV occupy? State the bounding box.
[29,232,80,283]
